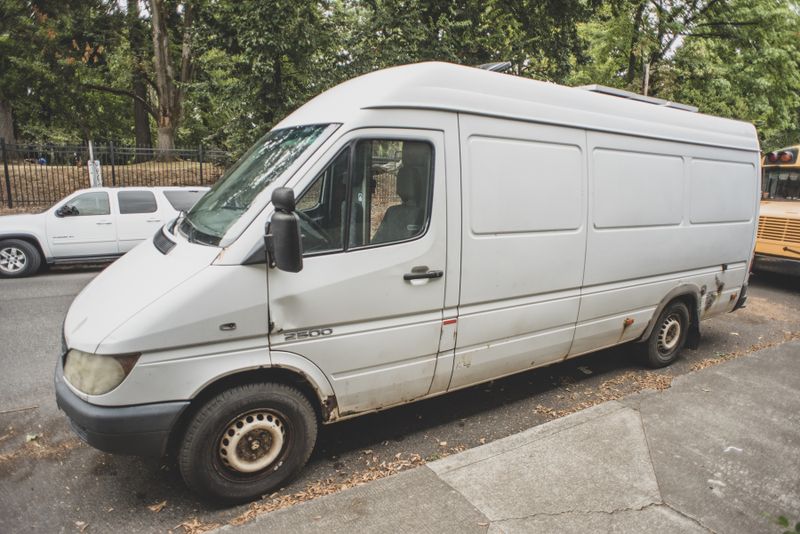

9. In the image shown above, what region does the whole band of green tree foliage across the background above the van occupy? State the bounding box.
[0,0,800,153]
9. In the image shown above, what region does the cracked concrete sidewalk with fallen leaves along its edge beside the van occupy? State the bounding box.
[223,342,800,534]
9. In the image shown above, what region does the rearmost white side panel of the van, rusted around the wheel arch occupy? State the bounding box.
[570,132,759,356]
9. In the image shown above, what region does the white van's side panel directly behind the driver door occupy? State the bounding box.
[450,115,587,389]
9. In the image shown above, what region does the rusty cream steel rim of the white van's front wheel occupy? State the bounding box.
[218,410,287,474]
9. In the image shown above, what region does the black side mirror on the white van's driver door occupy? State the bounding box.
[265,187,303,273]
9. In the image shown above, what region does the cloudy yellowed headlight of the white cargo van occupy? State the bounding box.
[64,349,140,395]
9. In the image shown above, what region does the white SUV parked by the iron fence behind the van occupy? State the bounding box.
[0,187,209,277]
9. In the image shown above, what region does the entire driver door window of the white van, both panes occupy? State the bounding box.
[297,139,433,254]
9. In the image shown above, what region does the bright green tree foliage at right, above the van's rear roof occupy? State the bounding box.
[569,0,800,149]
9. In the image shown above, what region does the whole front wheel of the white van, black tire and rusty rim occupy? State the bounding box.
[178,382,317,502]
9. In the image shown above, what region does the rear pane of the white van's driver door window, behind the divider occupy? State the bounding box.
[349,139,433,247]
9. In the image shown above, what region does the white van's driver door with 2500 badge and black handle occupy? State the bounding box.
[269,130,446,415]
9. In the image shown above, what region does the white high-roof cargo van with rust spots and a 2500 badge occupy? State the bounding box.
[56,63,759,500]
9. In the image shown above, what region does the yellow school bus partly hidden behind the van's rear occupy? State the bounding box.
[754,145,800,275]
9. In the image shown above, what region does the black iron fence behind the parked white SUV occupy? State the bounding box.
[0,139,233,208]
